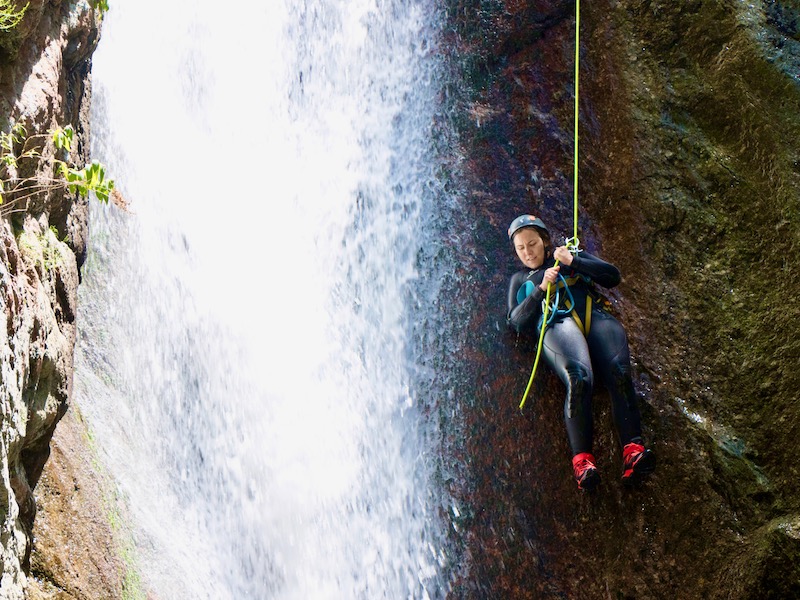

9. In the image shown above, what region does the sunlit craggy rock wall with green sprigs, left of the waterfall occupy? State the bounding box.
[0,0,99,599]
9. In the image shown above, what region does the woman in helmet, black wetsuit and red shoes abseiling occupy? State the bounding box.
[508,215,656,490]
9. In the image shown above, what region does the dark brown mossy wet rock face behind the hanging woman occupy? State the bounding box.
[440,0,800,599]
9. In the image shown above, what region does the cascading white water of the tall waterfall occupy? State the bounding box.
[76,0,460,599]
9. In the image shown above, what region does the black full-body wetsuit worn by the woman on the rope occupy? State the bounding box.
[508,252,642,455]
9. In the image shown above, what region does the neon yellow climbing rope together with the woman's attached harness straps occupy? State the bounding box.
[519,0,580,410]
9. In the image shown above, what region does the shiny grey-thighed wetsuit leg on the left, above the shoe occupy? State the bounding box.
[542,318,594,456]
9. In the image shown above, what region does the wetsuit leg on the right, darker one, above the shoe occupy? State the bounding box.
[587,309,642,446]
